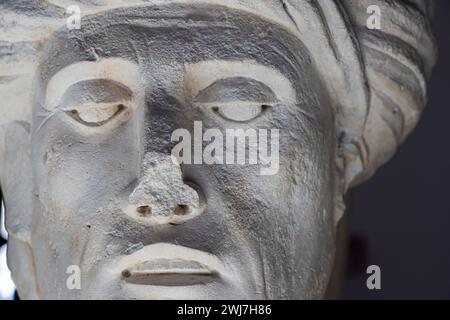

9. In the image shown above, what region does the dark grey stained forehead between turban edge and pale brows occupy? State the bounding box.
[40,4,308,86]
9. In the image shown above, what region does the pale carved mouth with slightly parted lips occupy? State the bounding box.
[115,243,223,286]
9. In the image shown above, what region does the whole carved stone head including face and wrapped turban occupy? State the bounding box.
[0,0,436,299]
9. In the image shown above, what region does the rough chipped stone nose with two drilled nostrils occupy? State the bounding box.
[126,152,206,225]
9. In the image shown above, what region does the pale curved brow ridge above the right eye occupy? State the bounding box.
[186,60,297,103]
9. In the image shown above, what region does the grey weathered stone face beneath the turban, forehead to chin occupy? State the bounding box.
[28,7,336,299]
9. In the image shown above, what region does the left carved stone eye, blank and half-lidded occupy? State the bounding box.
[66,103,127,127]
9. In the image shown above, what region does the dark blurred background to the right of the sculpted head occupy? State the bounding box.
[344,0,450,299]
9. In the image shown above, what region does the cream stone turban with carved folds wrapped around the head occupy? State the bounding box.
[0,0,436,189]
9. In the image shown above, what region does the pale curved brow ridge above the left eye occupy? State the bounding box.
[44,58,140,110]
